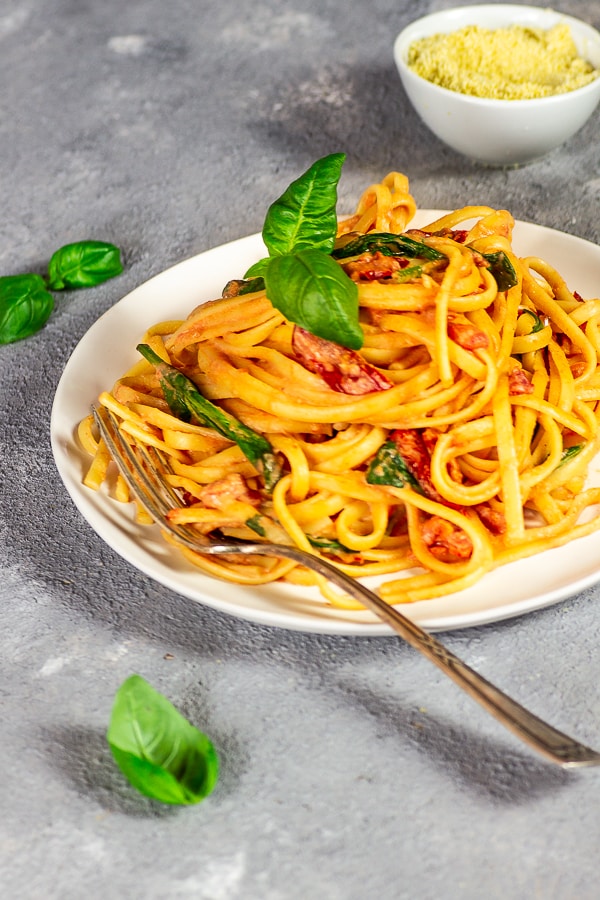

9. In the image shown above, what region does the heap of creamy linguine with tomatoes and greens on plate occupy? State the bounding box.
[79,162,600,608]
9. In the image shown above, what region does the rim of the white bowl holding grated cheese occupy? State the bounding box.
[393,3,600,109]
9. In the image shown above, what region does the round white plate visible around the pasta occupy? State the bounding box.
[51,210,600,635]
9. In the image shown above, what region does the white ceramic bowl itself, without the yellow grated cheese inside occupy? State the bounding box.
[394,3,600,166]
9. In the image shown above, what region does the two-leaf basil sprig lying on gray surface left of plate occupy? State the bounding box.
[0,241,123,344]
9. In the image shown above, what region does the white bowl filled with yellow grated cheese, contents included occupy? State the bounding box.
[394,3,600,166]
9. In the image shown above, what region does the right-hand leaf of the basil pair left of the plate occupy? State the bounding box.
[48,241,123,291]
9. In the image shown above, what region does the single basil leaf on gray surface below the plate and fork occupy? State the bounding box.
[106,675,219,805]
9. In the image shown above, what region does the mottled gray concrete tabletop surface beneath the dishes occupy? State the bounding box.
[0,0,600,900]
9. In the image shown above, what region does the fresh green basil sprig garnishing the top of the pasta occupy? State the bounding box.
[245,153,364,350]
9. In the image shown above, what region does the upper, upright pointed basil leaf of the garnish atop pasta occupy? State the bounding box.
[260,153,346,258]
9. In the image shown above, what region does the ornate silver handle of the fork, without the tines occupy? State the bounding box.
[227,544,600,768]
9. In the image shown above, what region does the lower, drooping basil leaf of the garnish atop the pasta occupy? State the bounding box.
[265,249,364,350]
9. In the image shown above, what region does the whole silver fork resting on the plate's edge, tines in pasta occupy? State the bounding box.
[93,406,600,769]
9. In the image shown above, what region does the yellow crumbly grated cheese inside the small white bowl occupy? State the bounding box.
[408,25,600,100]
